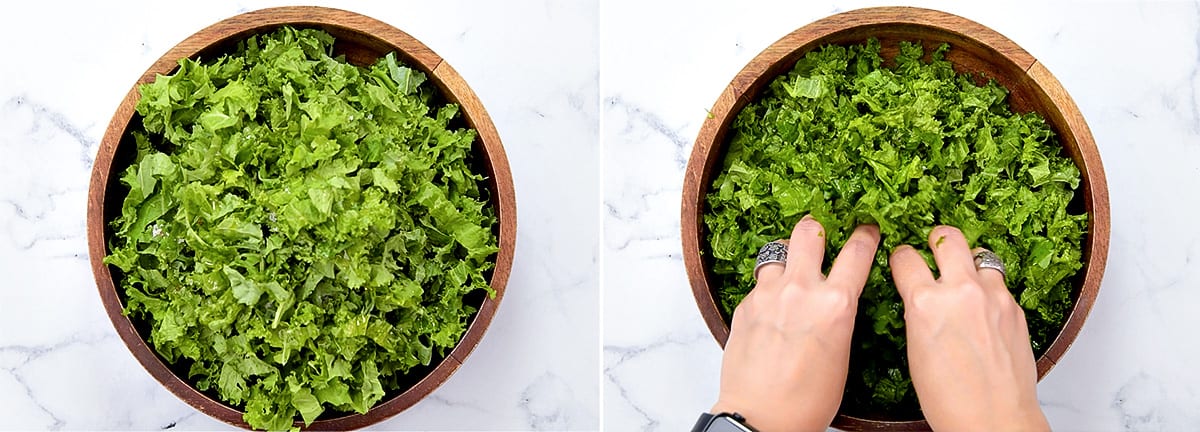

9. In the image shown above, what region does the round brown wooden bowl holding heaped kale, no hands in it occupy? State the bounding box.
[88,7,516,430]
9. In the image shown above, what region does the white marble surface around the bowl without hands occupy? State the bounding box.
[0,0,600,431]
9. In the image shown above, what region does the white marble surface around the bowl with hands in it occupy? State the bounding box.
[600,0,1200,431]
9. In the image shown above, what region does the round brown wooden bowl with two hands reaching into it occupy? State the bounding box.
[682,7,1109,431]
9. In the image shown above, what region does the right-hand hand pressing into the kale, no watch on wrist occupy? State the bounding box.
[892,227,1050,431]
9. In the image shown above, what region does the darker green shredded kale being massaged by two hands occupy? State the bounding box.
[704,40,1087,418]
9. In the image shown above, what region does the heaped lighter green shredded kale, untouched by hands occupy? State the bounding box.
[104,28,497,430]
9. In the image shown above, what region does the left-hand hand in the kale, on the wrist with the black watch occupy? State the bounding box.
[713,216,880,432]
